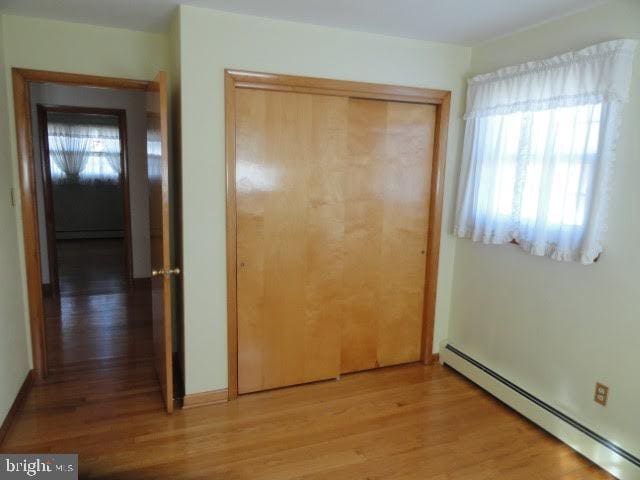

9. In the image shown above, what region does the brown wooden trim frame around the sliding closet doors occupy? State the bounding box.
[225,69,451,399]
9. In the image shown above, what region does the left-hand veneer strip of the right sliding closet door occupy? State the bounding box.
[341,99,387,373]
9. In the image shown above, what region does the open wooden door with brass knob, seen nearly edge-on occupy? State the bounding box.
[147,72,174,413]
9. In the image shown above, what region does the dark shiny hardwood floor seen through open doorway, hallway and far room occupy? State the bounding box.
[44,239,153,371]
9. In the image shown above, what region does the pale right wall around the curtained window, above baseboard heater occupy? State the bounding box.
[449,0,640,455]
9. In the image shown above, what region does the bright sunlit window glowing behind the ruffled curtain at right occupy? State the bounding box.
[479,104,601,226]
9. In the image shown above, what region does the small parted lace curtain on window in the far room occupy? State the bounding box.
[48,121,121,182]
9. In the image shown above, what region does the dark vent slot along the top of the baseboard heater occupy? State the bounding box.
[443,344,640,467]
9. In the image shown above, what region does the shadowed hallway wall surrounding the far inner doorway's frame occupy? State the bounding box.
[31,83,151,283]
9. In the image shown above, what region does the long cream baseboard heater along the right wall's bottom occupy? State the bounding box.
[440,343,640,480]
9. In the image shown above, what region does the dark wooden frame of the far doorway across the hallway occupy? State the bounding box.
[36,103,133,297]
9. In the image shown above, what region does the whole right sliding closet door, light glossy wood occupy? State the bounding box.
[341,99,436,373]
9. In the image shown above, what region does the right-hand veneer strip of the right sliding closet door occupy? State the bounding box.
[378,102,436,366]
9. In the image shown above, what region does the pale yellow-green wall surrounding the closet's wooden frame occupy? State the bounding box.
[180,6,470,393]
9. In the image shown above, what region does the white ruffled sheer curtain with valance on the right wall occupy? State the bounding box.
[454,40,637,264]
